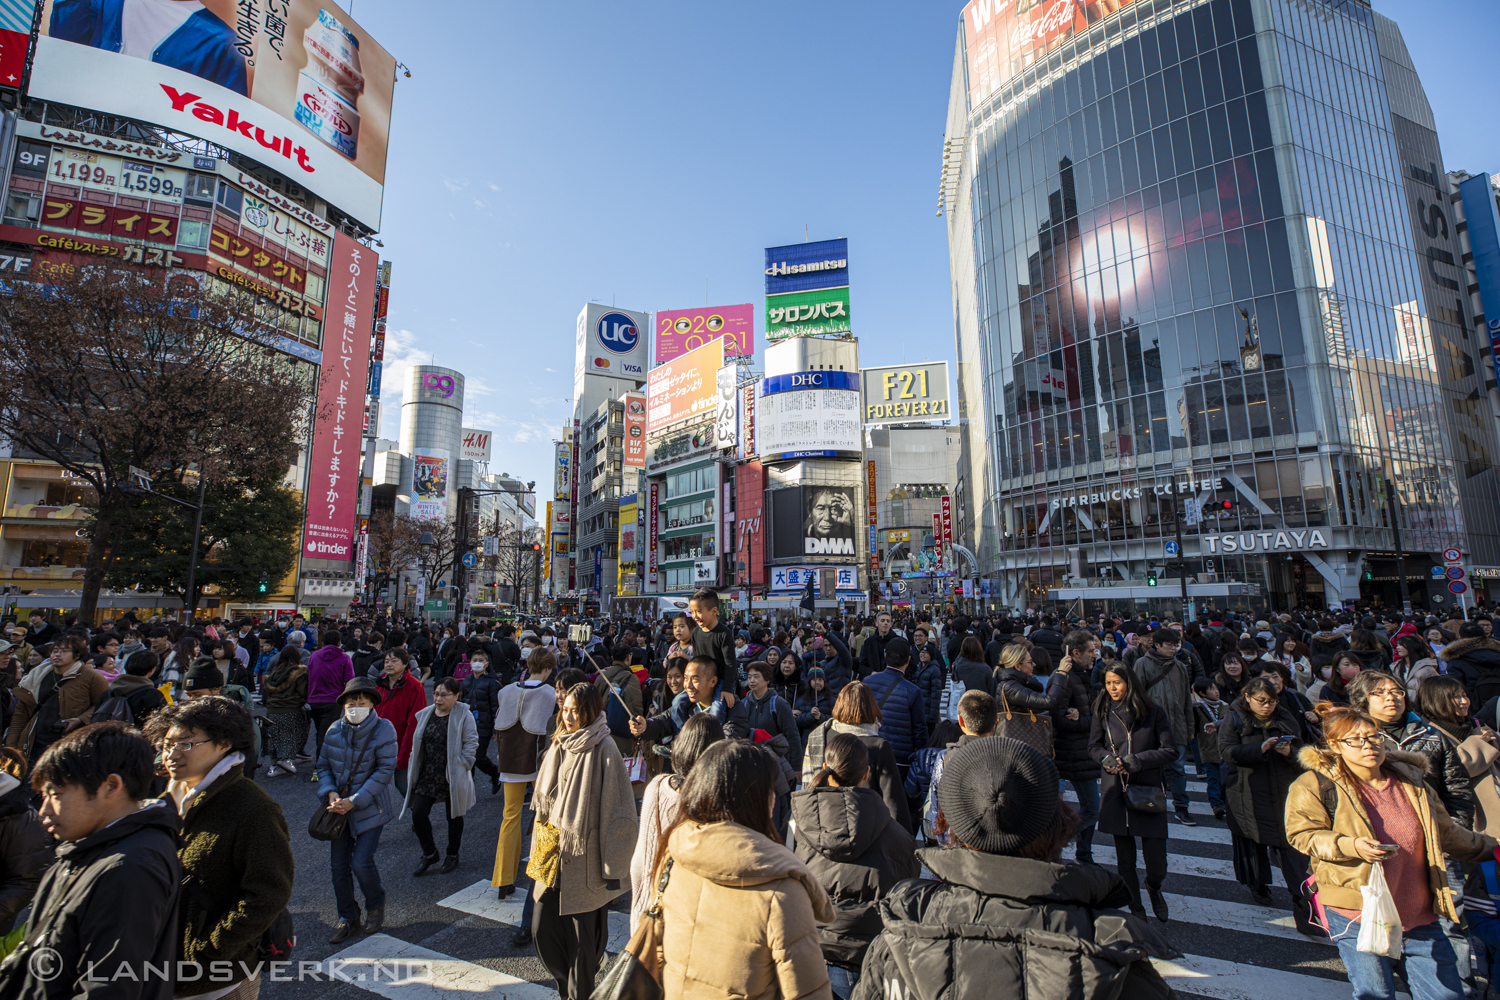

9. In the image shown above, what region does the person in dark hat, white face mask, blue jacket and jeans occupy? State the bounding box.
[318,678,399,945]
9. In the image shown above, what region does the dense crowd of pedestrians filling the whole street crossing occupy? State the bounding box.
[0,591,1500,1000]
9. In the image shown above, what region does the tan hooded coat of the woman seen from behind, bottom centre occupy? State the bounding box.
[662,822,834,1000]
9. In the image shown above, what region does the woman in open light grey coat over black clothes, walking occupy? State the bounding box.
[401,678,479,876]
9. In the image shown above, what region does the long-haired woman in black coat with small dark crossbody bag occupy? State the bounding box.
[1089,664,1178,921]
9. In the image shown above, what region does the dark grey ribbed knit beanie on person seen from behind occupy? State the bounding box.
[938,736,1062,855]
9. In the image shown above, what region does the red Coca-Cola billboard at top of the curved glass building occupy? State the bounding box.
[963,0,1136,108]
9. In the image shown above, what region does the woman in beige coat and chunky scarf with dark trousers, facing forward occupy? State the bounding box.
[531,684,636,1000]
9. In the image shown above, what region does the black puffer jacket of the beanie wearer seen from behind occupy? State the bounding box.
[854,850,1179,1000]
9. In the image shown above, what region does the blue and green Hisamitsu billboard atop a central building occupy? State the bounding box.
[765,240,851,342]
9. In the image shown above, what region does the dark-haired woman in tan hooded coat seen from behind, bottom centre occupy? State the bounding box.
[654,741,834,1000]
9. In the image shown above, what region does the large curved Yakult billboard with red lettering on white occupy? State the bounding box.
[30,0,396,229]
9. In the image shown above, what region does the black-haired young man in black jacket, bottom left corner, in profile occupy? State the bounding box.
[0,723,183,1000]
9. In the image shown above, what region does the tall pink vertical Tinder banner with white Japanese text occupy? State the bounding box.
[302,232,380,559]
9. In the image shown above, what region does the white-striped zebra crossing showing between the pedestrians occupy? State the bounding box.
[319,777,1350,1000]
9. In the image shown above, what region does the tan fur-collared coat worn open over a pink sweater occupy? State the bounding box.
[1287,745,1496,921]
